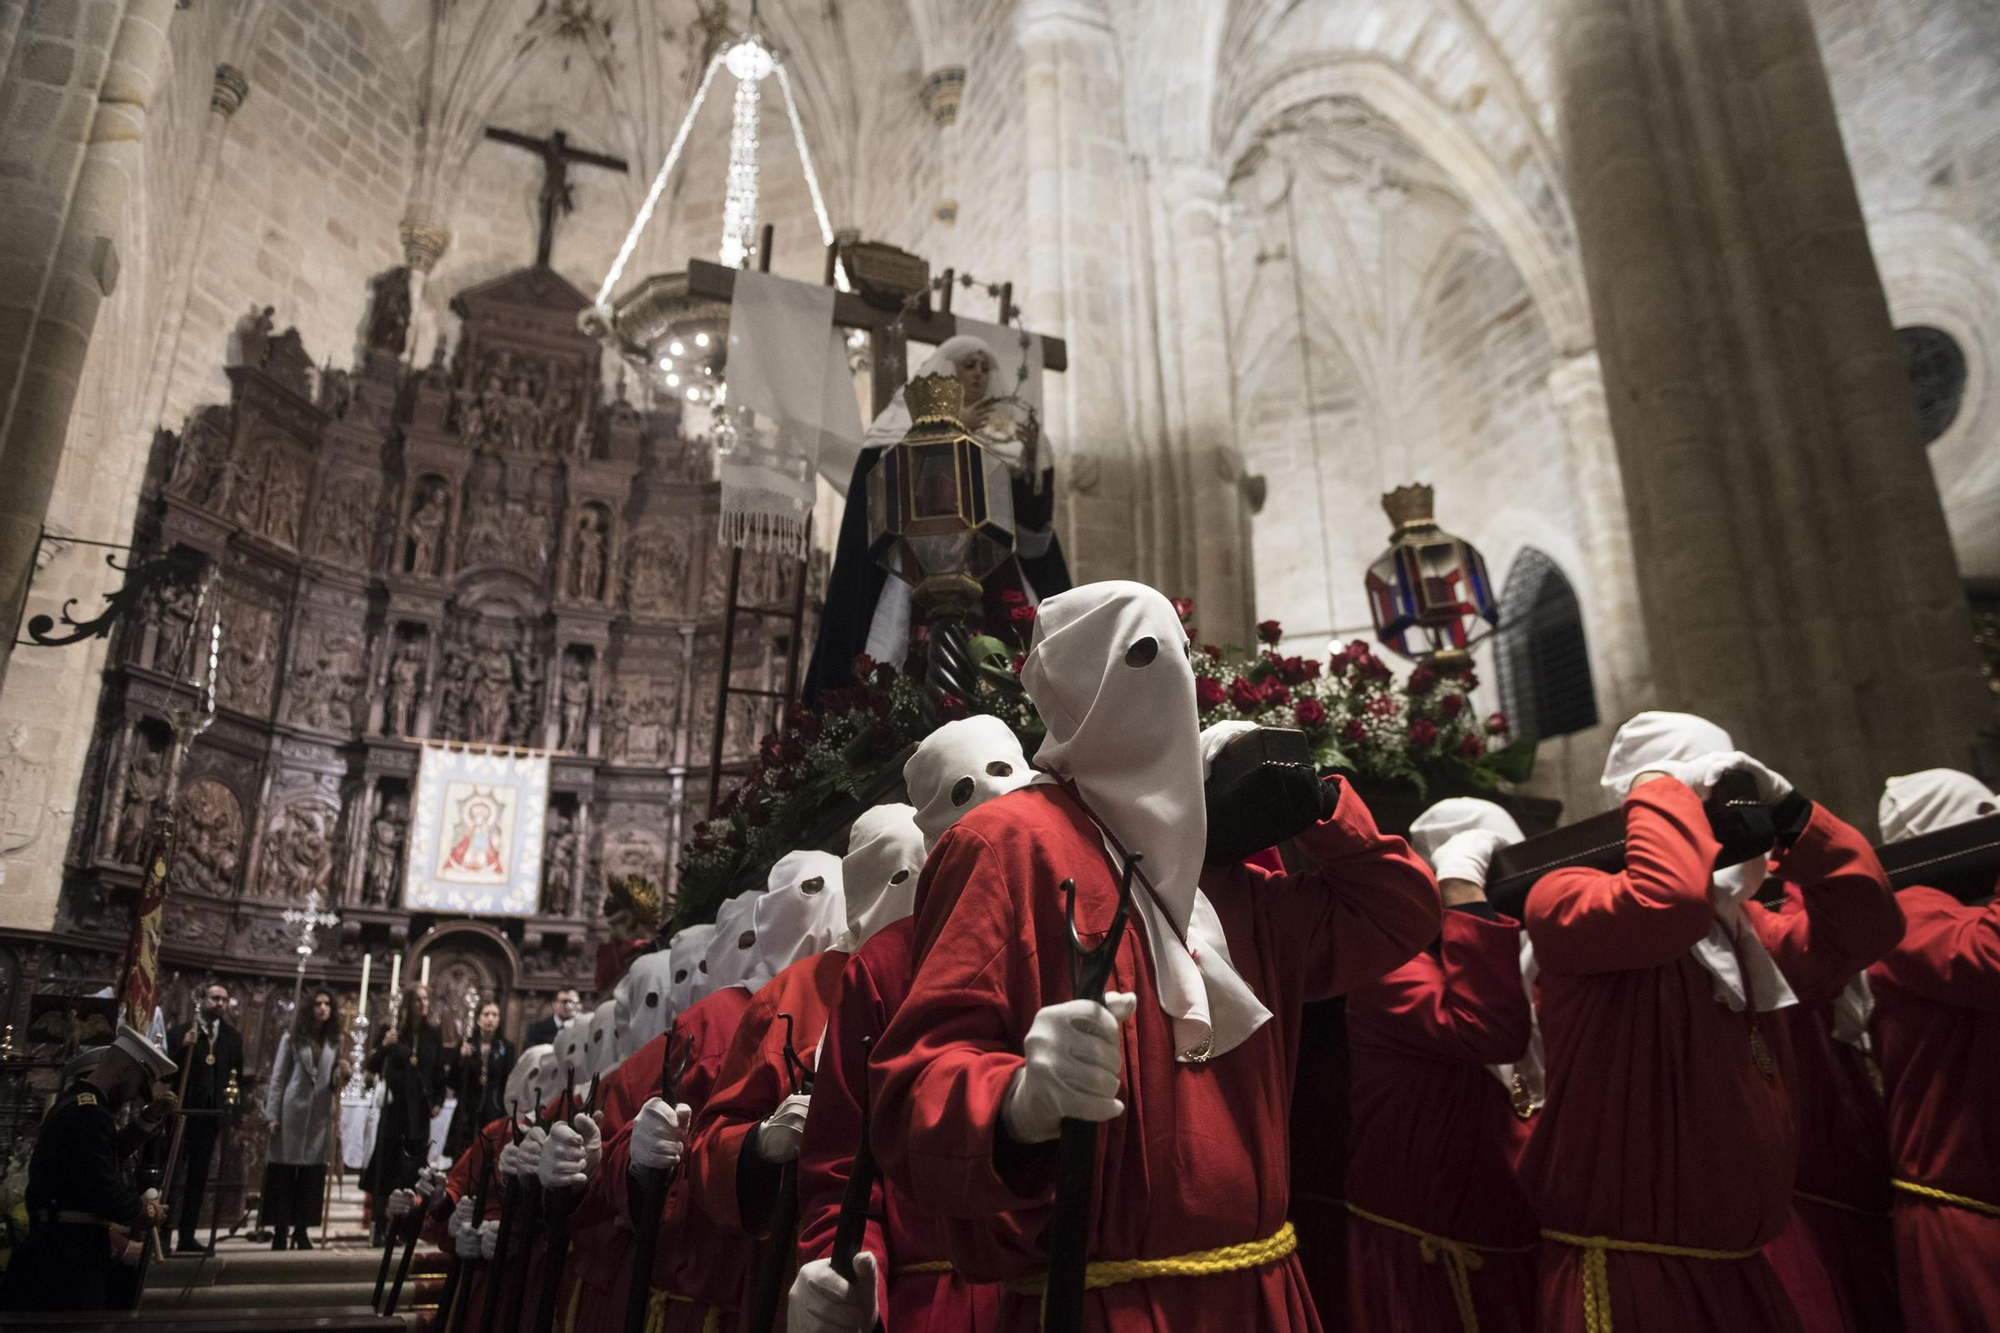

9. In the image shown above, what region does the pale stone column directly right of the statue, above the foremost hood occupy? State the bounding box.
[1014,0,1148,582]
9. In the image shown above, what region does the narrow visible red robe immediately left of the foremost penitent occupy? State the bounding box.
[798,917,1000,1333]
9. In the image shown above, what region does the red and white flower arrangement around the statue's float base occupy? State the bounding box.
[678,592,1534,921]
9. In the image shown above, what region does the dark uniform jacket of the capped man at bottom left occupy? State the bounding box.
[0,1079,142,1311]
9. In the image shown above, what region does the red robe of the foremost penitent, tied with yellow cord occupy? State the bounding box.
[874,787,1438,1333]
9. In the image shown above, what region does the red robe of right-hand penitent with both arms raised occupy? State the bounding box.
[1522,779,1902,1333]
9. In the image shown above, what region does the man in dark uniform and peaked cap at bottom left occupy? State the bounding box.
[0,1023,174,1313]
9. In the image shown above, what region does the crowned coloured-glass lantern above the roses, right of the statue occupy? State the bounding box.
[1368,482,1500,671]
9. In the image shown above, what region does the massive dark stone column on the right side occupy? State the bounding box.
[1550,0,1984,823]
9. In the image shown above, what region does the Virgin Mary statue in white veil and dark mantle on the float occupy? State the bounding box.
[804,334,1070,707]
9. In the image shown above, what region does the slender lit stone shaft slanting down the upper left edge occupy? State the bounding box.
[0,0,176,685]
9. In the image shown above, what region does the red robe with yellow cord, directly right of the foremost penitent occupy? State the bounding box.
[1348,909,1538,1333]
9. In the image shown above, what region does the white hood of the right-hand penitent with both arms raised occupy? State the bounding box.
[1602,713,1798,1013]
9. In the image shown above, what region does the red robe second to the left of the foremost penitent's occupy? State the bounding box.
[688,951,848,1311]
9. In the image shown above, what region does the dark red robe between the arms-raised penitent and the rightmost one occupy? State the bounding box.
[1770,885,1902,1333]
